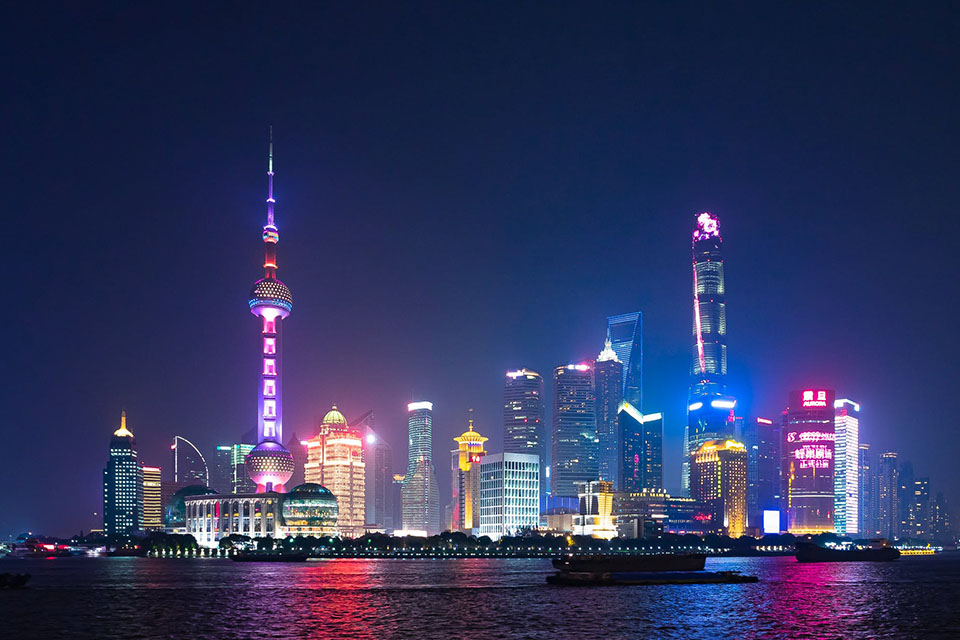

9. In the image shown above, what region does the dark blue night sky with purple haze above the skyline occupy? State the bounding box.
[0,3,960,537]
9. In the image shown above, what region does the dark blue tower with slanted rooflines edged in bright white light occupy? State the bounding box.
[615,400,663,492]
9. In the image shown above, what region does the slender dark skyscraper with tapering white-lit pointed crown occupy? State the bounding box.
[594,338,624,487]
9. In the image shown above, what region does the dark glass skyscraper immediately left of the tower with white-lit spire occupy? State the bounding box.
[550,364,599,498]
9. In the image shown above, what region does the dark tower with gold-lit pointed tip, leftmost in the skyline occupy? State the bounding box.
[103,411,143,534]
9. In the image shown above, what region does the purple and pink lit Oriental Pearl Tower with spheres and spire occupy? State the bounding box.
[246,127,294,493]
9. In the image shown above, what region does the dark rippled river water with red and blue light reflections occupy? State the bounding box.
[0,553,960,640]
